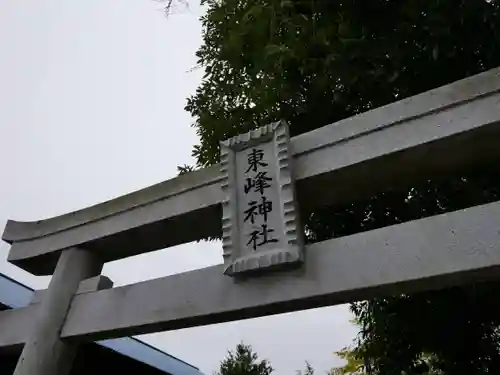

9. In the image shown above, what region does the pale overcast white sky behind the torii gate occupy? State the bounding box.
[0,0,356,375]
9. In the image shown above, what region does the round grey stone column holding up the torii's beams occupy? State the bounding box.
[14,248,103,375]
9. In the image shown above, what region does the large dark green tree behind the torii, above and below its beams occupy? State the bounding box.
[186,0,500,375]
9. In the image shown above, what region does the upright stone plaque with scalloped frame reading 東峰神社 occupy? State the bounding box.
[221,121,304,276]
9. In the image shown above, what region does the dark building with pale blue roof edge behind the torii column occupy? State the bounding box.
[0,274,203,375]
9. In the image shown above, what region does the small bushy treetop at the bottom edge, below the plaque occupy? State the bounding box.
[216,344,273,375]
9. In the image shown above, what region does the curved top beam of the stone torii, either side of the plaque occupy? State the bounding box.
[2,68,500,275]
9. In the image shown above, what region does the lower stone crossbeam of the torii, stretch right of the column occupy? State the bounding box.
[62,202,500,339]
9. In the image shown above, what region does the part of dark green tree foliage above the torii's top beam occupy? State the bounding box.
[187,0,500,166]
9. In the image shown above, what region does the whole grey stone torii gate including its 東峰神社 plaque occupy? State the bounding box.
[0,68,500,375]
